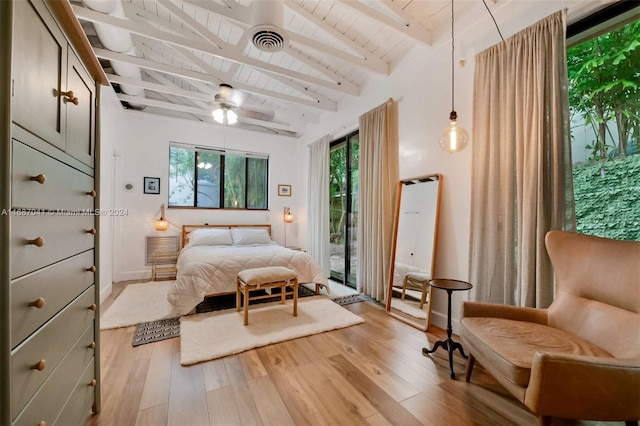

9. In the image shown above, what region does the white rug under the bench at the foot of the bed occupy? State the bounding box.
[180,296,364,365]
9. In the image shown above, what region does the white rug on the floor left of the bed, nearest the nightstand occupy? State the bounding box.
[100,281,177,330]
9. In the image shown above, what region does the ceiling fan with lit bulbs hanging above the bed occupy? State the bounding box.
[212,83,275,124]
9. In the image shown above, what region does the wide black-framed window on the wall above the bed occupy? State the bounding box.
[169,144,269,210]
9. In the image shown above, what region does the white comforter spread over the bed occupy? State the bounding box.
[167,244,327,315]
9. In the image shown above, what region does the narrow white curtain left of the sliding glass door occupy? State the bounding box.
[307,135,331,277]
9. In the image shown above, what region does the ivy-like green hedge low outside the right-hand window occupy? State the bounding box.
[573,155,640,241]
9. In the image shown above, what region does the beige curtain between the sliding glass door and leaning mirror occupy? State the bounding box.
[357,100,399,301]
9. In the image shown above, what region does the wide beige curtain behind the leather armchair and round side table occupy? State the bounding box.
[469,11,575,308]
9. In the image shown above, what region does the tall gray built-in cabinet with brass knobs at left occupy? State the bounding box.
[0,0,100,425]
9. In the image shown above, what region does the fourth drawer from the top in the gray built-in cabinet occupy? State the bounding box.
[11,286,95,413]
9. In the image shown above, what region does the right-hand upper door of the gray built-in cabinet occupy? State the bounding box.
[63,49,95,167]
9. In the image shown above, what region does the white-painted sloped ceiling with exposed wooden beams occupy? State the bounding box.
[71,0,496,137]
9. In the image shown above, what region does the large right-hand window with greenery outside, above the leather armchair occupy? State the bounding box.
[567,2,640,240]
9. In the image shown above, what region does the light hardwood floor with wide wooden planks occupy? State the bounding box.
[87,286,624,426]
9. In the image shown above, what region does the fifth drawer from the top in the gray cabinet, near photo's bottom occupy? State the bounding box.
[13,323,94,425]
